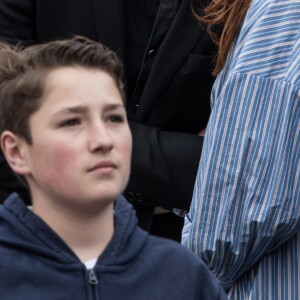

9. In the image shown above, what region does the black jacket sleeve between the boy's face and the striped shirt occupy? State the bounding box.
[125,122,203,210]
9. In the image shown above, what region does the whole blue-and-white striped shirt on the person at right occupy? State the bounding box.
[182,0,300,300]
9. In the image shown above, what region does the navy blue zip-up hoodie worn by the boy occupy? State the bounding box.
[0,194,226,300]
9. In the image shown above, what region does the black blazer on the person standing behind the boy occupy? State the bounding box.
[0,0,214,225]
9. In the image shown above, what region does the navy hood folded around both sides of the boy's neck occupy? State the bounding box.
[0,194,148,271]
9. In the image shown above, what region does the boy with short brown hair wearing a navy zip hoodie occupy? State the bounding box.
[0,37,225,300]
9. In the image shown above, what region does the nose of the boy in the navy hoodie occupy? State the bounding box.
[89,124,113,152]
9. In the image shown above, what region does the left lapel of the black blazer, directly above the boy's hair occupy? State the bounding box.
[92,0,126,57]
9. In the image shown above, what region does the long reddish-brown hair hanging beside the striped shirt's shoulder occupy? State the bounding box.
[193,0,251,75]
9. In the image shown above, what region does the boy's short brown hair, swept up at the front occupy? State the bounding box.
[0,36,125,144]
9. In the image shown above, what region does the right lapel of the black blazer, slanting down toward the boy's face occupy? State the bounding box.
[136,0,204,121]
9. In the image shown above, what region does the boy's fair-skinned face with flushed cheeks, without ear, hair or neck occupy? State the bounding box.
[19,67,132,210]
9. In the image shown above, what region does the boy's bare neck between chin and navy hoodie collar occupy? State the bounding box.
[33,202,114,262]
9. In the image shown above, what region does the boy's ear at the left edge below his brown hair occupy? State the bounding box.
[1,131,30,175]
